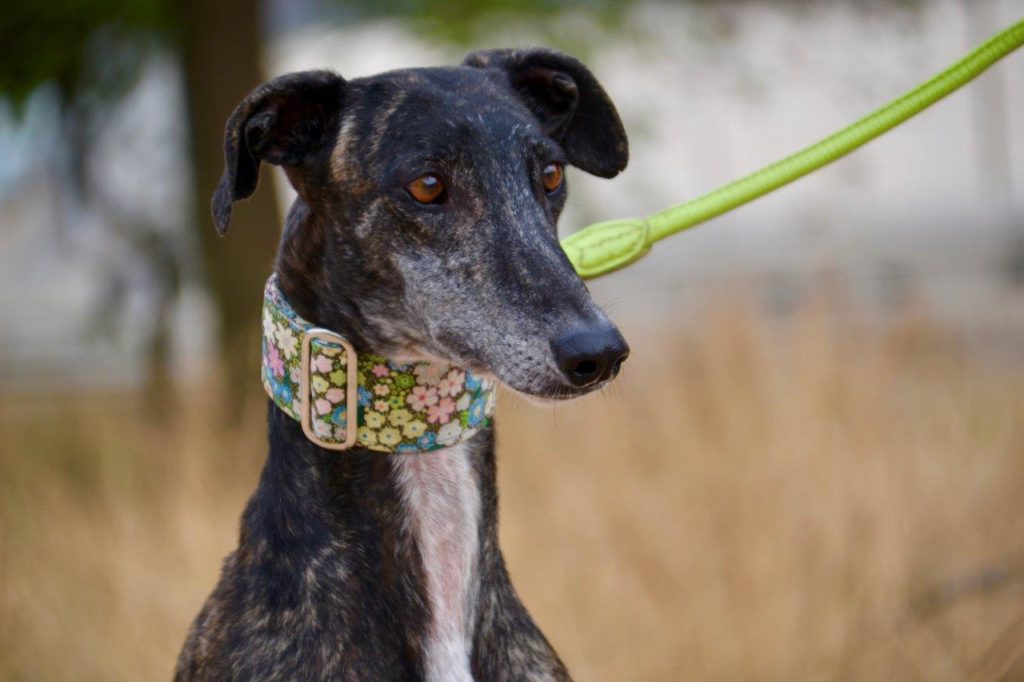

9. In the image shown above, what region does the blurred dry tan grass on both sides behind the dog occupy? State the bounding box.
[0,301,1024,681]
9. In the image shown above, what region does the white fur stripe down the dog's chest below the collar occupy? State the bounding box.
[392,443,480,682]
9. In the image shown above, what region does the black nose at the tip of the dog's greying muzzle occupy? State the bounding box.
[551,324,630,388]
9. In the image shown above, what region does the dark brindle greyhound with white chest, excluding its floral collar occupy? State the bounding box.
[176,49,629,681]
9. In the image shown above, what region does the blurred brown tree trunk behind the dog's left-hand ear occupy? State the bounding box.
[172,0,280,409]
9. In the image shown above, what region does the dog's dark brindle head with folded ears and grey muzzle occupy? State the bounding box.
[213,50,629,397]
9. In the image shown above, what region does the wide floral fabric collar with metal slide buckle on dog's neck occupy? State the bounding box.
[262,275,496,453]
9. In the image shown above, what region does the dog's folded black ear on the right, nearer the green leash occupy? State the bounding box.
[463,49,630,177]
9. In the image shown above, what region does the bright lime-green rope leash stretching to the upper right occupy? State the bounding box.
[562,20,1024,280]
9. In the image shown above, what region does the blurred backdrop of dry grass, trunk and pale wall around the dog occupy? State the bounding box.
[0,0,1024,681]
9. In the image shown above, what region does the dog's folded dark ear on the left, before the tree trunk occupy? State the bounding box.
[212,71,345,236]
